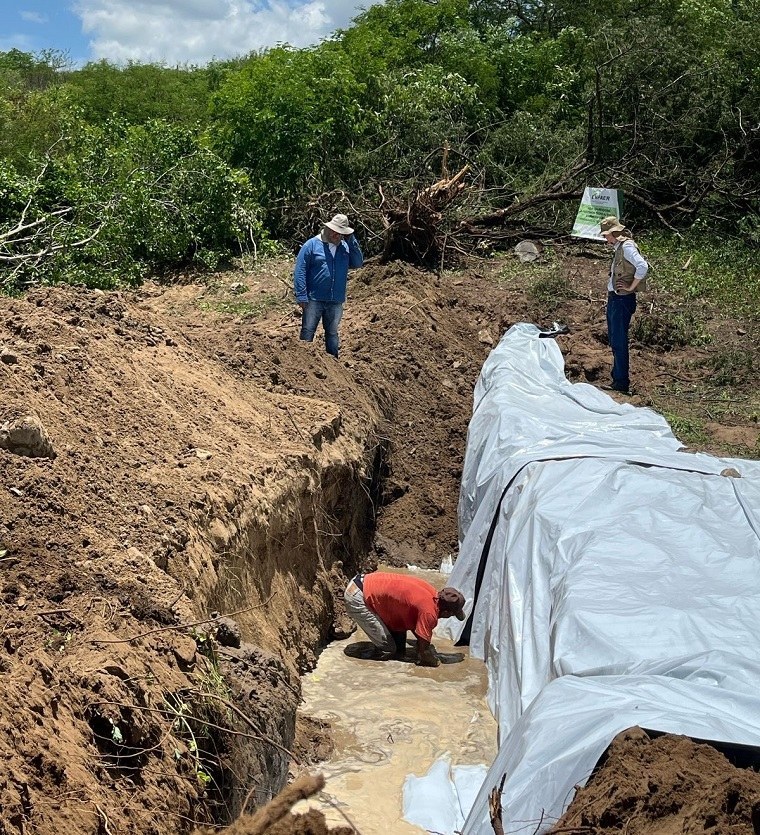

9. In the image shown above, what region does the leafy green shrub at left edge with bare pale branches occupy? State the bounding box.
[0,121,273,291]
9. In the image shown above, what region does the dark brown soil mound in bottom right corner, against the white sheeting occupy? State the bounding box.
[550,728,760,835]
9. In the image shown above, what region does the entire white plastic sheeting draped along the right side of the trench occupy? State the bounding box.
[422,324,760,835]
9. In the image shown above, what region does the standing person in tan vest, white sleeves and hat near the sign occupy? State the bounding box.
[599,215,649,394]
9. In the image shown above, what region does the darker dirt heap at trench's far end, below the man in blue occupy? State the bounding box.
[189,264,504,566]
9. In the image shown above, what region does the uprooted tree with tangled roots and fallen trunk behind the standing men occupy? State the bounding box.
[291,136,732,274]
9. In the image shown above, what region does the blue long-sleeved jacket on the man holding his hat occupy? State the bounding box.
[293,235,364,303]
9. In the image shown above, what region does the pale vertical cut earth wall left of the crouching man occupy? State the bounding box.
[172,412,387,823]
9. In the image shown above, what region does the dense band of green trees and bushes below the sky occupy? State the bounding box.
[0,0,760,291]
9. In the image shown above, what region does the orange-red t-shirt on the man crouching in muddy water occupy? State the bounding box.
[364,571,438,641]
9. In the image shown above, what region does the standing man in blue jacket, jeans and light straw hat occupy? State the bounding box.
[293,215,364,358]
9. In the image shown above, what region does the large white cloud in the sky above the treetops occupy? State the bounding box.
[74,0,374,65]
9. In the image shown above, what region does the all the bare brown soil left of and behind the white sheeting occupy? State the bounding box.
[0,248,760,835]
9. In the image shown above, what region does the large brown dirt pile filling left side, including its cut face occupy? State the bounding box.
[0,289,360,833]
